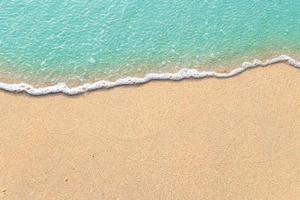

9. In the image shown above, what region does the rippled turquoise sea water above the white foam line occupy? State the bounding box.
[0,0,300,83]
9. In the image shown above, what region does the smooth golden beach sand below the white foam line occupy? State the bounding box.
[0,64,300,200]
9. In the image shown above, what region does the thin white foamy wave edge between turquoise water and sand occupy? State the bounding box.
[0,55,300,96]
